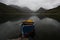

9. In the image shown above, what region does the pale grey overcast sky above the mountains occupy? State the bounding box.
[0,0,60,11]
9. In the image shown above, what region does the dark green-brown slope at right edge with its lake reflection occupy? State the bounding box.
[38,6,60,21]
